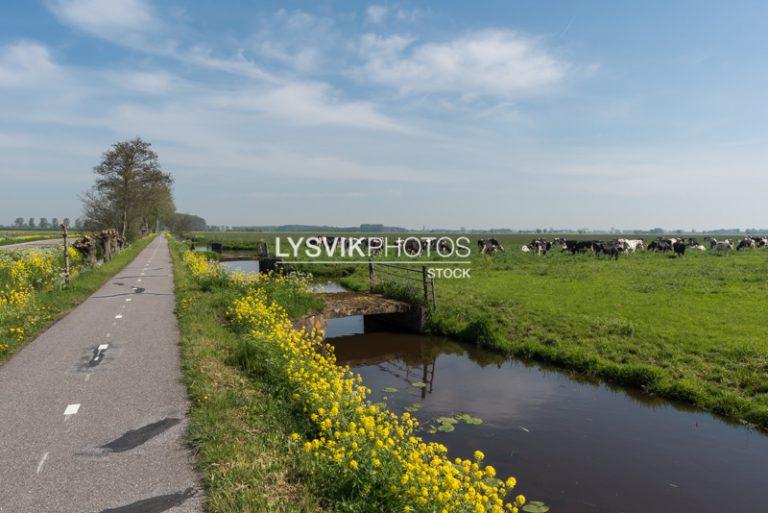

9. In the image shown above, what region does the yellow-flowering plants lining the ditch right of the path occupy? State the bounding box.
[184,252,525,513]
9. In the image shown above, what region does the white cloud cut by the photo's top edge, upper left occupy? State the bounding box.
[49,0,155,38]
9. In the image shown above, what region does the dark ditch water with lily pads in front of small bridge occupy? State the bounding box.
[332,333,768,513]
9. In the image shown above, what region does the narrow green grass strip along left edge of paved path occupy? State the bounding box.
[0,237,153,365]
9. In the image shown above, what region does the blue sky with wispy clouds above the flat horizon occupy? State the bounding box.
[0,0,768,228]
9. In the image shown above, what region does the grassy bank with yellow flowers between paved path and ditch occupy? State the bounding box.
[172,244,525,513]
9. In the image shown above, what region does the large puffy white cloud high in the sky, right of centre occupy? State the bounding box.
[358,30,569,99]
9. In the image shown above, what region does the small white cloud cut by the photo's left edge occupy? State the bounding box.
[0,41,62,87]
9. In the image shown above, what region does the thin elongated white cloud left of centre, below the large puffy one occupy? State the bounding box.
[217,82,407,132]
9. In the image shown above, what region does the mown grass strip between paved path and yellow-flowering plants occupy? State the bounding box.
[171,242,323,513]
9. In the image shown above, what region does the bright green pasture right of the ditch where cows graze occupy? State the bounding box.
[190,232,768,428]
